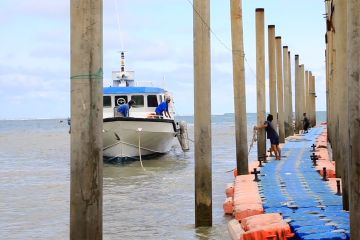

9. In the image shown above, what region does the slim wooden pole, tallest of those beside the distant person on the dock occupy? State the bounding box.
[295,55,304,133]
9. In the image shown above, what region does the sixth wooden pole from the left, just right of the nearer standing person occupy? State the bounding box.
[275,36,285,143]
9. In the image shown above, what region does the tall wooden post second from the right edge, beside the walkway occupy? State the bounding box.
[334,0,348,210]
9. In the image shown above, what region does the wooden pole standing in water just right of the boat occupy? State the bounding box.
[193,0,212,227]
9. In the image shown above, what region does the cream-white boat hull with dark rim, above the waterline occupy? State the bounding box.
[103,117,177,160]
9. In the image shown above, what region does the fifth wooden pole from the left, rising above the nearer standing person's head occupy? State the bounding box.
[268,25,277,130]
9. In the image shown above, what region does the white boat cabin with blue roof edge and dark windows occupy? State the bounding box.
[103,86,174,118]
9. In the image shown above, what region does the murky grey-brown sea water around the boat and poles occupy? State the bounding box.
[0,112,326,240]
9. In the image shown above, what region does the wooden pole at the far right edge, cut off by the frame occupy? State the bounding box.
[344,0,360,234]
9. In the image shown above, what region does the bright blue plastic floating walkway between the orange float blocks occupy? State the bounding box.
[229,127,350,240]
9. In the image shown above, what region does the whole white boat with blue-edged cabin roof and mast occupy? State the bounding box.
[103,52,189,161]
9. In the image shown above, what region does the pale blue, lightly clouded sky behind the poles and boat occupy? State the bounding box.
[0,0,326,119]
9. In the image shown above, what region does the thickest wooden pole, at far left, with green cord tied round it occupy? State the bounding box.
[70,0,103,240]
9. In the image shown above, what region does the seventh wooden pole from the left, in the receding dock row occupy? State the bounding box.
[283,46,292,137]
